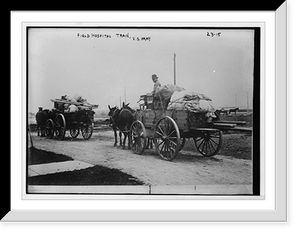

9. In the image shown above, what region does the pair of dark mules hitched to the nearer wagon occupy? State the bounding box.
[108,102,136,149]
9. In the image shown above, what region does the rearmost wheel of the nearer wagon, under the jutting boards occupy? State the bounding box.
[194,129,223,157]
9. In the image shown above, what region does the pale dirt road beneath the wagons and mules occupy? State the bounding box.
[32,130,252,194]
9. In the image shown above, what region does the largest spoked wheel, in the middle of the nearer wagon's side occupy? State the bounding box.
[154,116,181,161]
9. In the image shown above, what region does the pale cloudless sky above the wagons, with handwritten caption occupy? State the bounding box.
[28,28,254,113]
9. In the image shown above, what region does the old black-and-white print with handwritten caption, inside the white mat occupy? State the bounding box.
[26,25,261,196]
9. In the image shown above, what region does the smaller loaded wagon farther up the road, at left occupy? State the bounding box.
[45,99,98,140]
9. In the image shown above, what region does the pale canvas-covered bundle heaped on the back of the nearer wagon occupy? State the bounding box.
[168,90,215,112]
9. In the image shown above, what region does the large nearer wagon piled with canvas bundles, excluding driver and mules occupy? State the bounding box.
[130,89,250,161]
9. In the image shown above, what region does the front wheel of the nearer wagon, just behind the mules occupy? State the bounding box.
[129,120,147,154]
